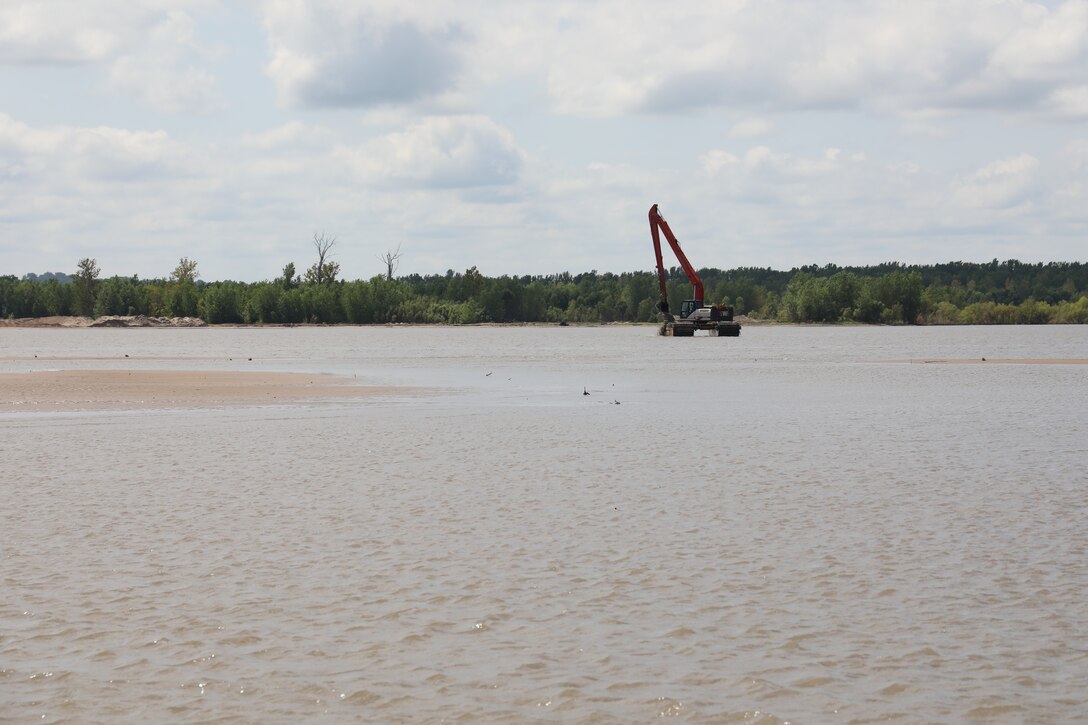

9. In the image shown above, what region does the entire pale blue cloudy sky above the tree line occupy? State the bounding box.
[0,0,1088,282]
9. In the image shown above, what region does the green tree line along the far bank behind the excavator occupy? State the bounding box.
[0,253,1088,324]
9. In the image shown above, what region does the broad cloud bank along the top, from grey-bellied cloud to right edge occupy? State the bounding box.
[250,0,1088,121]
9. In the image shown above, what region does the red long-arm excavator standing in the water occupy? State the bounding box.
[650,204,741,337]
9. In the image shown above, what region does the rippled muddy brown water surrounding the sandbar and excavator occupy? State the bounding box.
[0,328,1088,723]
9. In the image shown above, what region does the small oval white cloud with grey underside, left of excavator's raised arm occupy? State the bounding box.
[343,115,523,188]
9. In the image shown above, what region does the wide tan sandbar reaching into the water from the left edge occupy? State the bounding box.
[0,370,394,413]
